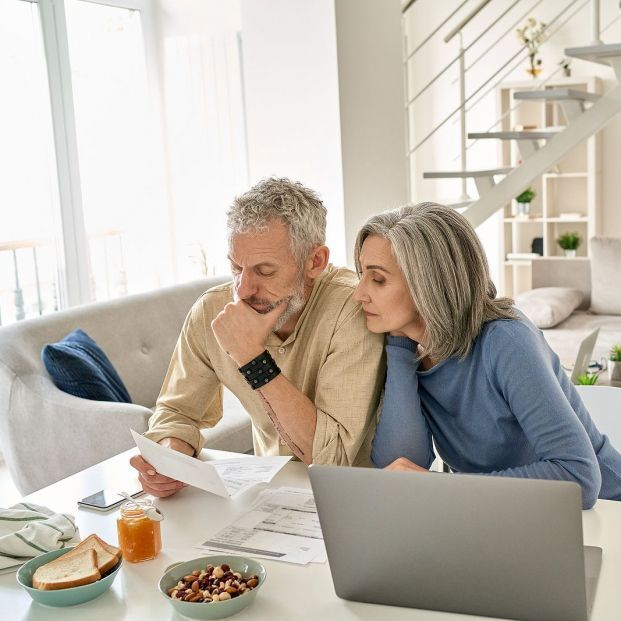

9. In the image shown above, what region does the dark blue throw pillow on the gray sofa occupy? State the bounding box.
[41,329,132,403]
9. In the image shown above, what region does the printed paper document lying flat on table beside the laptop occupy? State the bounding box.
[197,487,327,565]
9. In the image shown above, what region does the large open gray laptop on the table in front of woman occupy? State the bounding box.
[309,465,602,621]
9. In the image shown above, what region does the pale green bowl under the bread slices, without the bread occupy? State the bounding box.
[17,548,123,606]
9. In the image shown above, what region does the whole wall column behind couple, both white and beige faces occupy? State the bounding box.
[242,0,407,265]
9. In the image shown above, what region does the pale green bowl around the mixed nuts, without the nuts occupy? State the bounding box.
[158,554,267,620]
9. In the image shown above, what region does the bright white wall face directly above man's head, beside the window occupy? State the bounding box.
[241,0,345,263]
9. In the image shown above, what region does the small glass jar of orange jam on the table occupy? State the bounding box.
[116,500,163,563]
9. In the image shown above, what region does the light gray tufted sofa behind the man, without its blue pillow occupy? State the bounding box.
[0,277,252,494]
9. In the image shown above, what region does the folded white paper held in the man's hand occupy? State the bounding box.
[132,429,291,498]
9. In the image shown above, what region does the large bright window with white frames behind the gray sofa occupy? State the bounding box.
[0,0,248,324]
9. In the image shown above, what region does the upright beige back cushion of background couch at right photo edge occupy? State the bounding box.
[591,237,621,315]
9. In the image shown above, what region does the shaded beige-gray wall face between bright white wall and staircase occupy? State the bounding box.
[336,0,408,265]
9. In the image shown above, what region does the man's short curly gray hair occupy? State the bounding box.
[226,177,327,266]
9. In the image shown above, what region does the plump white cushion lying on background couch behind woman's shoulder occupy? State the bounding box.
[515,287,583,328]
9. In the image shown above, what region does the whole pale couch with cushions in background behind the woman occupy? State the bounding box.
[516,237,621,364]
